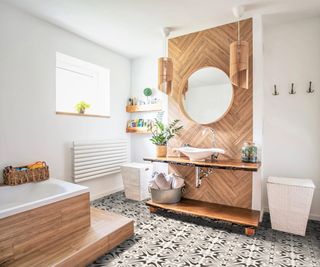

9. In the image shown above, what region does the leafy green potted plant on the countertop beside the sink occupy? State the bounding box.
[149,119,183,157]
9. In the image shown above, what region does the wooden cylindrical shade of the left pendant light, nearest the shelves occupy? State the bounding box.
[158,57,173,95]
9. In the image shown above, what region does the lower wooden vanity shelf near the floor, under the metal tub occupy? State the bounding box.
[146,199,260,227]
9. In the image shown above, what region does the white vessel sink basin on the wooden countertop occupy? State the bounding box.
[175,146,225,161]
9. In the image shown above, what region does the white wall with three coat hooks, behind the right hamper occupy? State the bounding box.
[263,17,320,219]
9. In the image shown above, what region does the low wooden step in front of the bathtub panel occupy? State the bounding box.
[4,208,134,267]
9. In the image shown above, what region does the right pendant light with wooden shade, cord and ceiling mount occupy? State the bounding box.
[230,6,249,89]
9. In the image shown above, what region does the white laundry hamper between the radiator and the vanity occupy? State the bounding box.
[121,162,152,201]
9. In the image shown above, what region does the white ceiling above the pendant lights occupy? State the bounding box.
[0,0,320,58]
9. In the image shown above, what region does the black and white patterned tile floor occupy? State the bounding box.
[90,192,320,267]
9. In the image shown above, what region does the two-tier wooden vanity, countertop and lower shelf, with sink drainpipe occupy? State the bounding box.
[144,157,261,235]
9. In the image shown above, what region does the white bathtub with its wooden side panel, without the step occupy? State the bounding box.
[0,179,90,266]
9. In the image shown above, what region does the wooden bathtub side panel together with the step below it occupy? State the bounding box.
[0,193,134,267]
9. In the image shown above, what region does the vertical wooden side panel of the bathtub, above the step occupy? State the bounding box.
[0,193,90,265]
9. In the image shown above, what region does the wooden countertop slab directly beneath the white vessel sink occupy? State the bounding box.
[143,157,261,172]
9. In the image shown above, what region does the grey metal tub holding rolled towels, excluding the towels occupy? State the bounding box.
[149,187,184,204]
